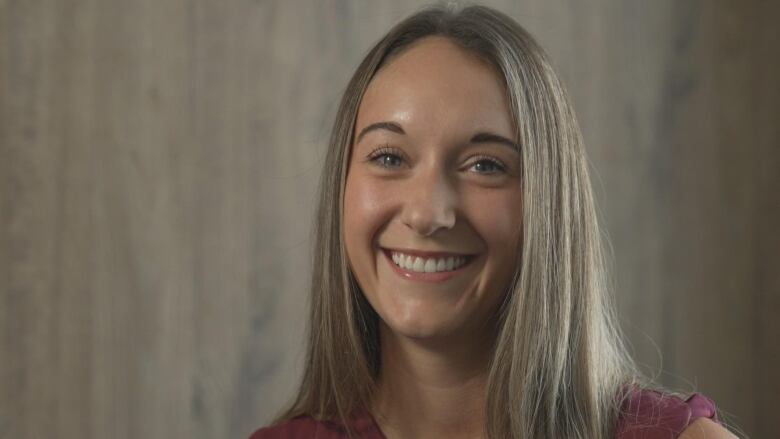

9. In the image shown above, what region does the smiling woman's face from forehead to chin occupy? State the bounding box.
[344,37,522,338]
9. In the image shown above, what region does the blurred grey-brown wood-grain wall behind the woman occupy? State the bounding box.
[0,0,780,438]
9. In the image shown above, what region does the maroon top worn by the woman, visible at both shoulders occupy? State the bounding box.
[249,390,720,439]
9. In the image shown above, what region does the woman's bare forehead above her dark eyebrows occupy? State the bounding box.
[357,37,512,141]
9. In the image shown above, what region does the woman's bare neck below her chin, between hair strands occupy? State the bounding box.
[372,322,492,439]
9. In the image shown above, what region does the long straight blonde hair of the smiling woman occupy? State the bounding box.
[275,4,639,439]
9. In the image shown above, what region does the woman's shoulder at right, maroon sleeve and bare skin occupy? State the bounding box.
[615,389,732,439]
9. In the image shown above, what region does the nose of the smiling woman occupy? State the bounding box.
[403,166,458,236]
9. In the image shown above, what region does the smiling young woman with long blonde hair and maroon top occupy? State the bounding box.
[252,6,734,439]
